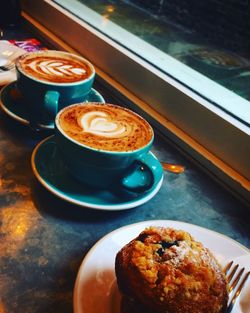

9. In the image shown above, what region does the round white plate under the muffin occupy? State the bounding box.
[74,220,250,313]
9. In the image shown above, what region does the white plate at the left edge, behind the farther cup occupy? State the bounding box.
[0,40,26,86]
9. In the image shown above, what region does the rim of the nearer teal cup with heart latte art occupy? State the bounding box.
[55,102,154,155]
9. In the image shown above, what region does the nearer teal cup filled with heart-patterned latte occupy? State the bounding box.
[55,103,163,192]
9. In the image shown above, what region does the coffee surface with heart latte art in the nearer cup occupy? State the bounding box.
[58,103,153,152]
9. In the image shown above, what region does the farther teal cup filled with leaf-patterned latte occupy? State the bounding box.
[16,50,95,125]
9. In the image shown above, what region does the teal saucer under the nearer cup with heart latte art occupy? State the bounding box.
[31,136,163,211]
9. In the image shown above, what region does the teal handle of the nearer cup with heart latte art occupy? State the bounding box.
[121,153,163,192]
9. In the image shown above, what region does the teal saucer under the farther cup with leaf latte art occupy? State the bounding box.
[0,82,105,129]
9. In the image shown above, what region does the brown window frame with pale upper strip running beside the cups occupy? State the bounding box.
[21,0,250,201]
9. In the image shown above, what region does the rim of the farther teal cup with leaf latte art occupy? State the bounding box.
[15,50,96,87]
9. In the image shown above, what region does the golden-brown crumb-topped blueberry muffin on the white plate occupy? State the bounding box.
[115,227,228,313]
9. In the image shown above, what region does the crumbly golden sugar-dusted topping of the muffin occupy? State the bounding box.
[131,227,219,297]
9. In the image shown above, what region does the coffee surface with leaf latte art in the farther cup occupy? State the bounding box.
[18,53,92,83]
